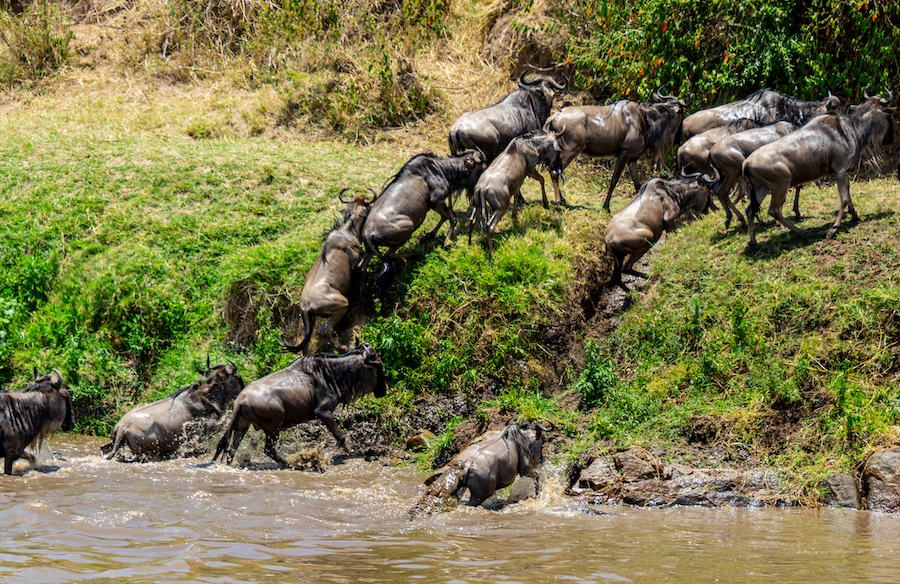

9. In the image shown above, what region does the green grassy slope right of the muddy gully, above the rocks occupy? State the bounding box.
[574,180,900,484]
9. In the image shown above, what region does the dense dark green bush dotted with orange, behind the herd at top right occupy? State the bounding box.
[560,0,900,106]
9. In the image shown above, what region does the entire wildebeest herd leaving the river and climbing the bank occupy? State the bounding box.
[0,74,894,515]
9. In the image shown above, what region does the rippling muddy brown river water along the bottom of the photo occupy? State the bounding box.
[0,436,900,584]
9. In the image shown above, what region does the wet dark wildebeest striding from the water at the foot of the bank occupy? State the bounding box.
[213,343,387,466]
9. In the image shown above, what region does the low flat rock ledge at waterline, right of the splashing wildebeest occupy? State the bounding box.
[569,448,797,507]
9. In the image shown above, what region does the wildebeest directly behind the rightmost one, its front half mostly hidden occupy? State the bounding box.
[709,122,800,229]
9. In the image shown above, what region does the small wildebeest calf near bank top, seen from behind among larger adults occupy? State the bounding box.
[469,131,559,256]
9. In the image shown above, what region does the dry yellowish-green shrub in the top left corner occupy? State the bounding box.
[0,0,74,85]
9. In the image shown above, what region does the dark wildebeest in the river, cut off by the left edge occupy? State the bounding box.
[0,369,74,474]
